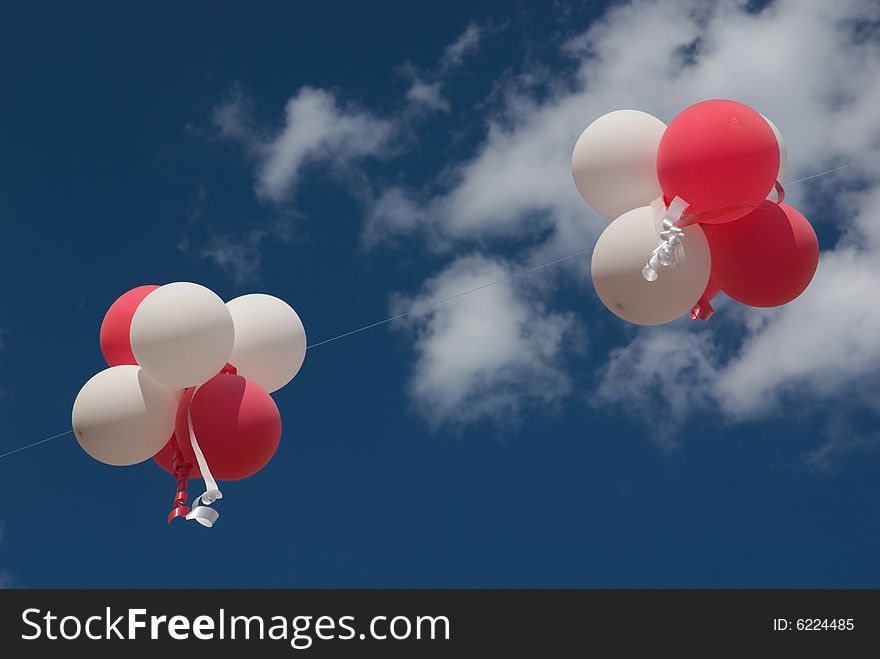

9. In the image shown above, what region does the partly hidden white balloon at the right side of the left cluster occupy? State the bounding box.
[226,293,306,393]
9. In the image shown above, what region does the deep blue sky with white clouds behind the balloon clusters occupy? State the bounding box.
[0,1,880,587]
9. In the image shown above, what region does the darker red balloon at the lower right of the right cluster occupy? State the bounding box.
[705,201,819,307]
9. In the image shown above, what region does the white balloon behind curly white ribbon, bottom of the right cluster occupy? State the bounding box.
[592,206,711,325]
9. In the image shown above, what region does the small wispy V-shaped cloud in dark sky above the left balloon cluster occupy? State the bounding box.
[212,87,393,204]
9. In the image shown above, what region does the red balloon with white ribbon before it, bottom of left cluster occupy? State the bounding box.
[175,373,281,480]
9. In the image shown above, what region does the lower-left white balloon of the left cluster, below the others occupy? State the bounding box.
[71,364,177,466]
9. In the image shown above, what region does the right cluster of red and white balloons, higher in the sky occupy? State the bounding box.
[572,100,819,325]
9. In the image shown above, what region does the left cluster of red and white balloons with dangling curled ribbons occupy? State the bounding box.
[72,282,306,526]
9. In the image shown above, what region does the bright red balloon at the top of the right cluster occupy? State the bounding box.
[657,100,779,224]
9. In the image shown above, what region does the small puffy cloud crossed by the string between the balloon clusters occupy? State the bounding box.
[393,255,577,427]
